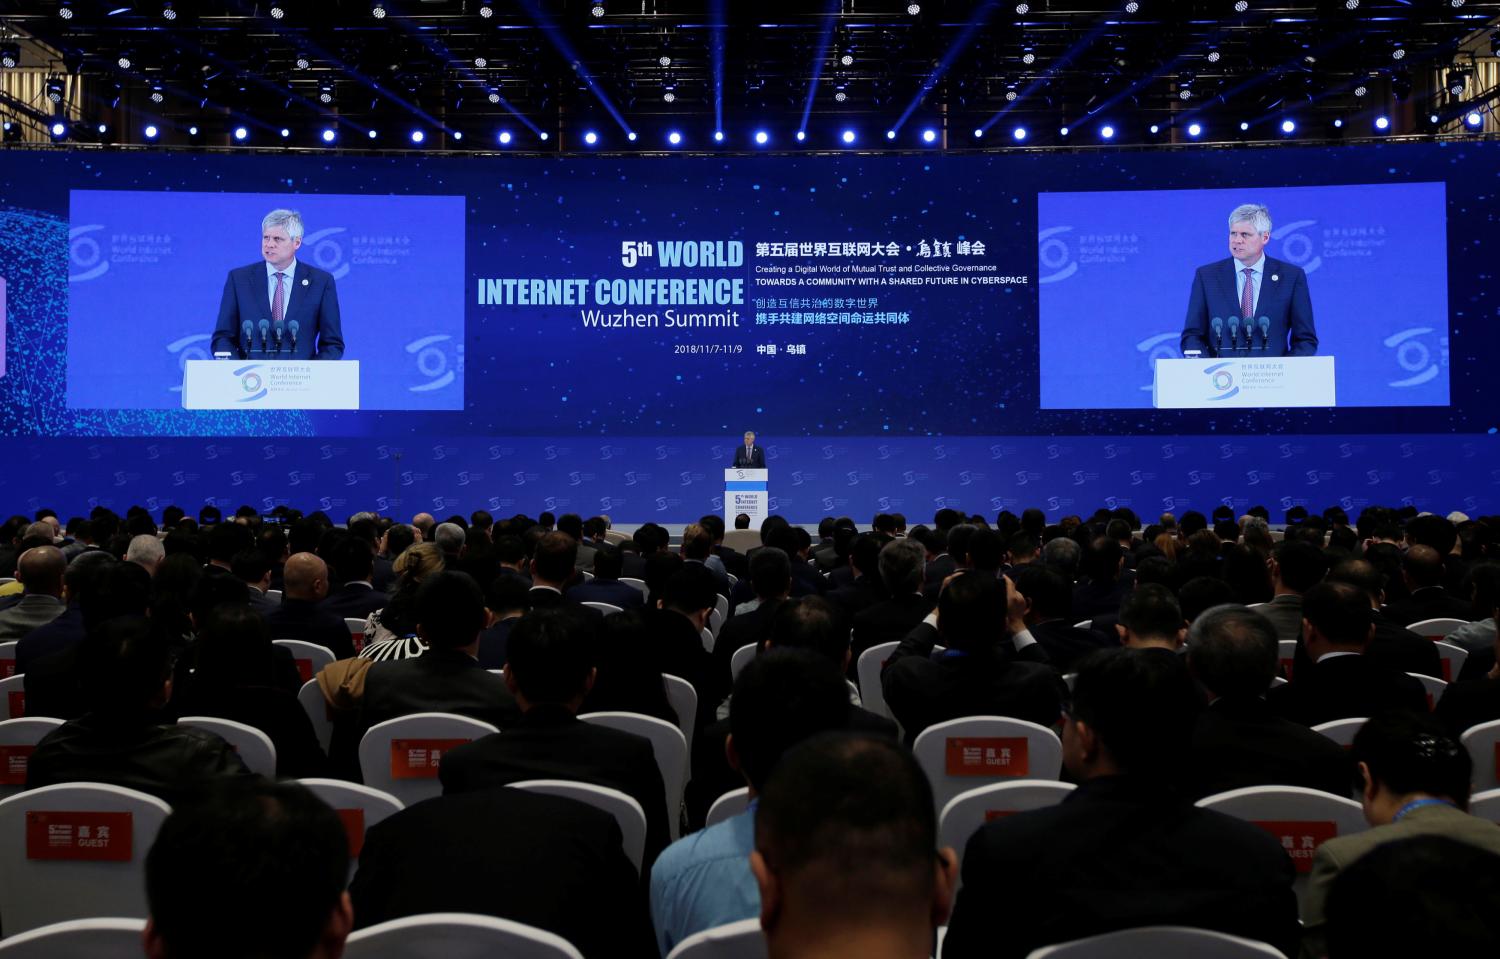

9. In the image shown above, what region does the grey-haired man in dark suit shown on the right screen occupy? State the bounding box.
[1181,203,1317,357]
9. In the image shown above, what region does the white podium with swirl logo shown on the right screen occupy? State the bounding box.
[1151,356,1335,410]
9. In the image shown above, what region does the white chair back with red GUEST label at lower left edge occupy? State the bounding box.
[0,782,171,935]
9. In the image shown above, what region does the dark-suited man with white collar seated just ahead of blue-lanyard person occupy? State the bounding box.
[1266,582,1427,726]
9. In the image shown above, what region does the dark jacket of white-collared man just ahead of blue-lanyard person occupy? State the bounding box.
[1266,656,1427,726]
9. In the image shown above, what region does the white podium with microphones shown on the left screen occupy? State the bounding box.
[183,359,360,410]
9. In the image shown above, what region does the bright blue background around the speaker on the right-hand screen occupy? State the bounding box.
[1037,183,1449,410]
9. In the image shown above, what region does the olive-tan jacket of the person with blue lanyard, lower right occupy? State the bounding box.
[1302,804,1500,956]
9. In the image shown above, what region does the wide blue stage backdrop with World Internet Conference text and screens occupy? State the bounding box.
[0,143,1500,522]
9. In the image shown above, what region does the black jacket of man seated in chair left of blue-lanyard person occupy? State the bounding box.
[1184,696,1355,800]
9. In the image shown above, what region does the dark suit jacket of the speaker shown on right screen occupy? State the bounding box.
[1181,257,1317,356]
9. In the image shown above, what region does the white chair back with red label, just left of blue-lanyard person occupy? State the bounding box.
[1197,786,1370,899]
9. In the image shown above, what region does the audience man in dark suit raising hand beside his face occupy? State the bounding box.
[881,572,1062,743]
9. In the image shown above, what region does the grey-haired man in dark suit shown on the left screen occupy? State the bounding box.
[213,210,344,360]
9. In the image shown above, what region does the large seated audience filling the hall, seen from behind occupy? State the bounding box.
[0,507,1500,959]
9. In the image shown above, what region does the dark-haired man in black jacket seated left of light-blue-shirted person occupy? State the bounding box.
[440,609,668,867]
